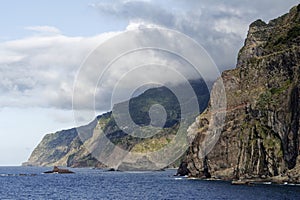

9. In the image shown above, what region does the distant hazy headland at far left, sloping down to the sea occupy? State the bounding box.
[23,120,101,167]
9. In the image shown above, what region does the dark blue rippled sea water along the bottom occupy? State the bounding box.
[0,167,300,200]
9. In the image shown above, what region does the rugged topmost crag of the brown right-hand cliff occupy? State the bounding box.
[237,4,300,67]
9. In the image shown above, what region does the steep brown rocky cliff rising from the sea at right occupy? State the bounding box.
[186,5,300,182]
